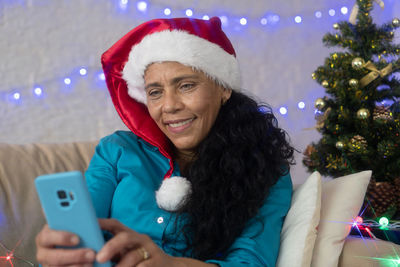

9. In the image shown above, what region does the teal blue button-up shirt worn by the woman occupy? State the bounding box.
[85,131,292,267]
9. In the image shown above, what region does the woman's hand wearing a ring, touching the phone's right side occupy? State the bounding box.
[96,219,178,267]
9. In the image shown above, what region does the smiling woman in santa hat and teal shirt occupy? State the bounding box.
[36,18,293,267]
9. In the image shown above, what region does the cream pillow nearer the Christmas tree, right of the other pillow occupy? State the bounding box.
[311,171,372,267]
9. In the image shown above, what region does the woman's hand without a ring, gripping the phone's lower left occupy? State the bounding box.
[36,224,96,266]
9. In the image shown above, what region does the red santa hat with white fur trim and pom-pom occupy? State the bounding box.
[102,17,240,211]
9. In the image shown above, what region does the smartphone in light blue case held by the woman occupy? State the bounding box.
[35,171,111,267]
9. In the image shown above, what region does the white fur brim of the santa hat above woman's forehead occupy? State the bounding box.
[122,30,240,103]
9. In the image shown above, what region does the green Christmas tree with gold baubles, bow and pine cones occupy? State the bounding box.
[303,0,400,219]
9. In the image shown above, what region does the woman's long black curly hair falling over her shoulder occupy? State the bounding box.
[171,91,294,260]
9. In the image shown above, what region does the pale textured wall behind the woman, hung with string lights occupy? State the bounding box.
[0,0,399,183]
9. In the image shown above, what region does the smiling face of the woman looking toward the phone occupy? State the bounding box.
[144,61,231,156]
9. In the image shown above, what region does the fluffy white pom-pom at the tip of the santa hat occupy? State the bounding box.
[156,176,192,211]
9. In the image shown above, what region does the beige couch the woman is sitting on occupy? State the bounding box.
[0,142,400,267]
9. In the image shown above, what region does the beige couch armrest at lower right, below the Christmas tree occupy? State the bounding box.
[339,236,400,267]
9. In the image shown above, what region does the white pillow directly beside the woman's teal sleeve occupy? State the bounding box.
[276,172,321,267]
